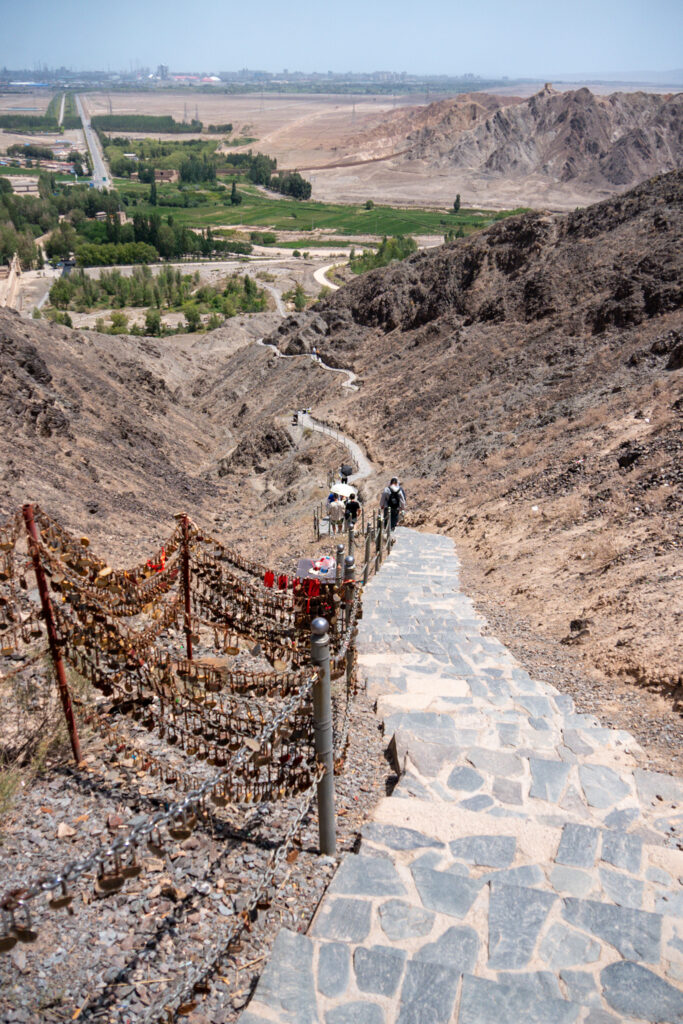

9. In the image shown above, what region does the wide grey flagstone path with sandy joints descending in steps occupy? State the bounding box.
[241,529,683,1024]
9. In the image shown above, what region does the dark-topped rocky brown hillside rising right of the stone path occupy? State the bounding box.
[270,172,683,700]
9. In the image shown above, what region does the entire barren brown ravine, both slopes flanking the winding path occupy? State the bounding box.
[0,172,683,745]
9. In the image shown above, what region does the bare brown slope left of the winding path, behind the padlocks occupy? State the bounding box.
[0,310,344,564]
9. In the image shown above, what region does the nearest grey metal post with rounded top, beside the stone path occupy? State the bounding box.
[310,617,337,855]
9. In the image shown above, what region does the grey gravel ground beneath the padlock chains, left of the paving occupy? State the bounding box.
[0,643,391,1024]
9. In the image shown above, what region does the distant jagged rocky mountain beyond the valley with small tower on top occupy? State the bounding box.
[405,86,683,191]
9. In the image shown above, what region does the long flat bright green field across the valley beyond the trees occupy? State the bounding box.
[115,178,523,238]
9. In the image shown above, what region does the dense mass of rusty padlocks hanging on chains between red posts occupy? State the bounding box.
[0,495,374,949]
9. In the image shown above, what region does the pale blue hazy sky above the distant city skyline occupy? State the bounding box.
[0,0,683,79]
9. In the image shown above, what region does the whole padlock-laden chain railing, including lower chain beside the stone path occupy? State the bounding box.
[0,493,392,1024]
